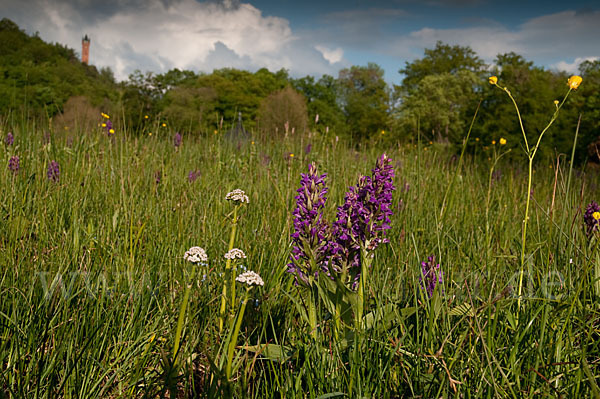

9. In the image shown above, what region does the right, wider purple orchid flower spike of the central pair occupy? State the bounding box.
[330,154,395,273]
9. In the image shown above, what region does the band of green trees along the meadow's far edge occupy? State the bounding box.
[0,19,600,161]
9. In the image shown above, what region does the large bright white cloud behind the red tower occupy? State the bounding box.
[7,0,341,79]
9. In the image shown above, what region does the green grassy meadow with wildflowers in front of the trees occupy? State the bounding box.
[0,111,600,399]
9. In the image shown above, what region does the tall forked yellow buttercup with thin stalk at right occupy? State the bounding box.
[488,75,582,310]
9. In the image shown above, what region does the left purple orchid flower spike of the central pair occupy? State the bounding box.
[287,164,329,284]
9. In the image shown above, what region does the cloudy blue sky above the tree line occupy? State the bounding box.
[0,0,600,84]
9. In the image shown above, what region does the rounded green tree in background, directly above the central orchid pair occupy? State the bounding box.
[338,63,390,139]
